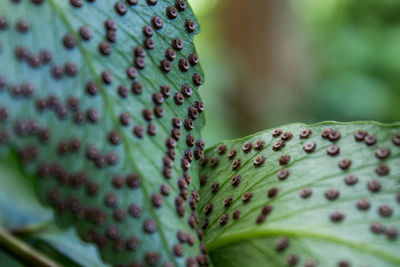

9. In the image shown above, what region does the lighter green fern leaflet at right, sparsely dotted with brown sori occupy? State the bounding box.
[198,122,400,266]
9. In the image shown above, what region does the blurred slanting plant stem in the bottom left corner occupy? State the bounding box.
[0,228,61,267]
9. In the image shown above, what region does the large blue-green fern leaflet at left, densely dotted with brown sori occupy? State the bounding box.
[0,0,208,266]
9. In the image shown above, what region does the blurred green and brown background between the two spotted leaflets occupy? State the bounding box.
[189,0,400,145]
